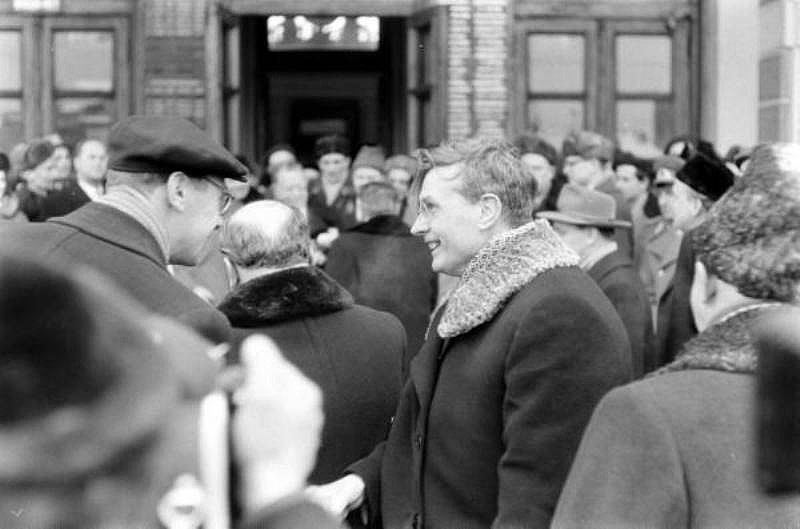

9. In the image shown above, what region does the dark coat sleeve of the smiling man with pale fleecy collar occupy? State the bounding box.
[492,296,630,529]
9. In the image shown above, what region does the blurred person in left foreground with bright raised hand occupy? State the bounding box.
[0,257,335,529]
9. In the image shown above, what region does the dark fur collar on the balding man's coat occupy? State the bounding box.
[219,266,353,327]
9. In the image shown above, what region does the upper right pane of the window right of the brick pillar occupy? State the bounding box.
[617,35,672,94]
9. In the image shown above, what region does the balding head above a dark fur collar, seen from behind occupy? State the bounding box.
[224,200,310,269]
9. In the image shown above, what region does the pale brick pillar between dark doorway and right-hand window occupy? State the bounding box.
[446,0,511,138]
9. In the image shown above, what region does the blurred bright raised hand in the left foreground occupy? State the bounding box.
[233,335,323,510]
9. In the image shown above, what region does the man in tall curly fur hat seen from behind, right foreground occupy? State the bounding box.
[553,144,800,529]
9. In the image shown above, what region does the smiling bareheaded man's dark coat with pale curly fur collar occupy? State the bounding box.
[349,221,631,529]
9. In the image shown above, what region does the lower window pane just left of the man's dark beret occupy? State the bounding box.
[55,97,116,145]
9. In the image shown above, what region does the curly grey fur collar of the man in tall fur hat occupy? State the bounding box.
[651,303,782,376]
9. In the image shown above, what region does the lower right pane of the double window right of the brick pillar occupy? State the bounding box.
[617,100,673,157]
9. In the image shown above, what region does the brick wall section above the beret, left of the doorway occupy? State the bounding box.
[144,0,206,128]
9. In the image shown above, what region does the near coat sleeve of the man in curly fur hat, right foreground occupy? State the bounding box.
[552,382,688,529]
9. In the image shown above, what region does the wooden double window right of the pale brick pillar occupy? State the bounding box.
[511,12,696,156]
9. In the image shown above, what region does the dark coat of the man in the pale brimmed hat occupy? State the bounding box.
[586,251,657,378]
